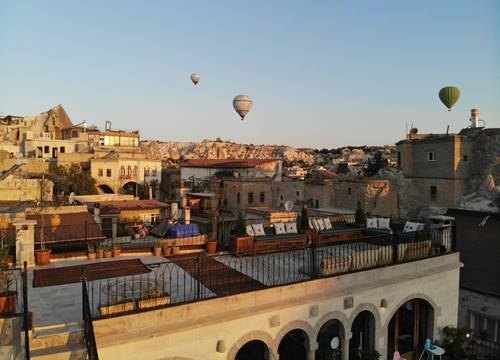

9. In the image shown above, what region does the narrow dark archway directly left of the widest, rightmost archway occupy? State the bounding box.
[349,310,375,360]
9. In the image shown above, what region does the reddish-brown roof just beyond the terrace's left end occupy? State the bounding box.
[26,212,105,245]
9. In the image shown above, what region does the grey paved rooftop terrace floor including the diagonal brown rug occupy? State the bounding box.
[28,243,388,327]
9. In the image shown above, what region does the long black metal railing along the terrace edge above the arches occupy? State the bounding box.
[87,229,453,318]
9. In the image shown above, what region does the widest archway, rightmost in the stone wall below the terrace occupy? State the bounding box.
[387,299,434,360]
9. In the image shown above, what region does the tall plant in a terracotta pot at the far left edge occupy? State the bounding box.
[0,228,17,314]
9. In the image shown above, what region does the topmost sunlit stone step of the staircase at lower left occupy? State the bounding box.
[30,325,83,349]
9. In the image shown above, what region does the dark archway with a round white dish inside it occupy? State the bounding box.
[315,319,345,360]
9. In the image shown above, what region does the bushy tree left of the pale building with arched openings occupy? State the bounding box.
[48,164,97,195]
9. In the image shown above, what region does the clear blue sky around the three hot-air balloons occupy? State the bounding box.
[0,0,500,148]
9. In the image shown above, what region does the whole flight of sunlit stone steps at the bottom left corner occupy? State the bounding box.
[30,323,87,360]
